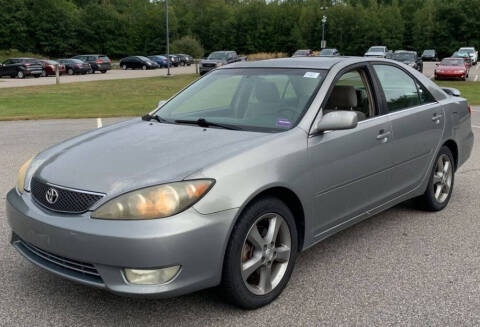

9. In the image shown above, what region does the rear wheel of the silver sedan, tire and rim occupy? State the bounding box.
[417,146,455,211]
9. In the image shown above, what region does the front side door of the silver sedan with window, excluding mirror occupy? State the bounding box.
[308,65,392,238]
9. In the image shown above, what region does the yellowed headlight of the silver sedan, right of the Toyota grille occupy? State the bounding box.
[92,179,214,219]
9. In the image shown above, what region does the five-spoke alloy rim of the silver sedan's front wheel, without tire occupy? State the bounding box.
[240,213,292,295]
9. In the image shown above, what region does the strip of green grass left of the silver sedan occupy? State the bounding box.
[0,75,197,120]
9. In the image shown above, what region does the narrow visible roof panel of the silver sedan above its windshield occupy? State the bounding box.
[225,57,362,69]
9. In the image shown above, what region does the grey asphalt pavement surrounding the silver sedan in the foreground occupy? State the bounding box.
[0,112,480,326]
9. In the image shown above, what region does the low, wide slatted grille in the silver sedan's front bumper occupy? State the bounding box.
[12,234,103,284]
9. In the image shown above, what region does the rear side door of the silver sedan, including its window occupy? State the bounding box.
[373,64,445,195]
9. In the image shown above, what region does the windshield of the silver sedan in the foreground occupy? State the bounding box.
[156,68,326,132]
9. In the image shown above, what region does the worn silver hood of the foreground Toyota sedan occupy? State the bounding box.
[32,119,275,195]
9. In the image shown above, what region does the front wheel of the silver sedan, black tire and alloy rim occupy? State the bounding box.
[221,197,298,309]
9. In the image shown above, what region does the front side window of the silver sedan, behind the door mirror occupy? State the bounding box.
[323,69,375,121]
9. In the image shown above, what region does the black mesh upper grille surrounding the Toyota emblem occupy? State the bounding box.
[30,178,103,213]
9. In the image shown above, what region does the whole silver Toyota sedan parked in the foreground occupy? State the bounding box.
[6,57,473,309]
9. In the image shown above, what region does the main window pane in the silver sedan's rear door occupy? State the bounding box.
[373,65,422,112]
